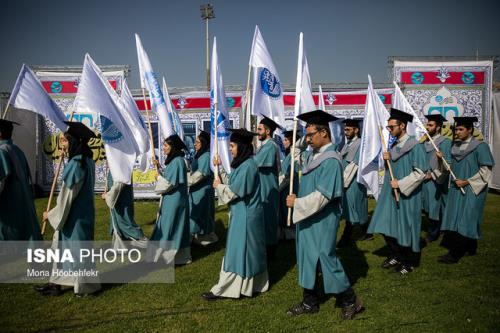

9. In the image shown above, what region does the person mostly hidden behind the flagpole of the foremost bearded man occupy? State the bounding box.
[278,131,302,239]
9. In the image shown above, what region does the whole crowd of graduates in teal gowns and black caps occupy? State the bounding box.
[0,105,494,319]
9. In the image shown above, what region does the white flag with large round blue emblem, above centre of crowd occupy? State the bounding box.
[249,26,285,124]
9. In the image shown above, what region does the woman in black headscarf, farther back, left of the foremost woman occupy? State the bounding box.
[188,131,218,246]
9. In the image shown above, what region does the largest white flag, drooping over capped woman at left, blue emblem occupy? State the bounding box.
[75,54,139,184]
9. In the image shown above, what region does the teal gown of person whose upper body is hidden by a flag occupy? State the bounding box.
[107,172,144,240]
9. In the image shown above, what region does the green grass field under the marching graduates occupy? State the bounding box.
[0,194,500,332]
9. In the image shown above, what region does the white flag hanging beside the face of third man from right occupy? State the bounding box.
[357,75,389,199]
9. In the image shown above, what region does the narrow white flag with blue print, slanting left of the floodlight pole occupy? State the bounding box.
[135,34,175,138]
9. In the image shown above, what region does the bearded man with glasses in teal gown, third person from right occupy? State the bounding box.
[368,109,428,275]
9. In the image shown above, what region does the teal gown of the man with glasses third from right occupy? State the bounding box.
[368,137,428,252]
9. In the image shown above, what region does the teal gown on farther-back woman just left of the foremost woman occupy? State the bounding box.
[189,151,215,235]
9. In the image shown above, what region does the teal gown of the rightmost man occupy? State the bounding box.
[441,142,495,239]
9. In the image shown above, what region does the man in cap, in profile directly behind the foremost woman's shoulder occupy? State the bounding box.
[254,116,281,259]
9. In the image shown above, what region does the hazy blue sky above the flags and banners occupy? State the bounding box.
[0,0,500,91]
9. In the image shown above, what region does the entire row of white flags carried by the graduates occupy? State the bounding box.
[2,26,425,198]
